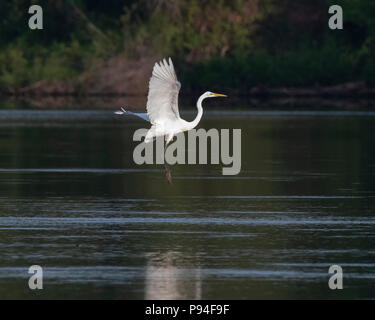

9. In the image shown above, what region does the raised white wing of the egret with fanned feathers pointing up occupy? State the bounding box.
[147,58,181,124]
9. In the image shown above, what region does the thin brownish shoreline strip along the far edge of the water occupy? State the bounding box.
[0,95,375,111]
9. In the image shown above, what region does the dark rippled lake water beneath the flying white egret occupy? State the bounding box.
[0,108,375,299]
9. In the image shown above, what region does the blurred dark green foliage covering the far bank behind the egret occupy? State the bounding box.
[0,0,375,90]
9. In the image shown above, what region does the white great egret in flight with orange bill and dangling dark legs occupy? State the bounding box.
[115,58,226,182]
